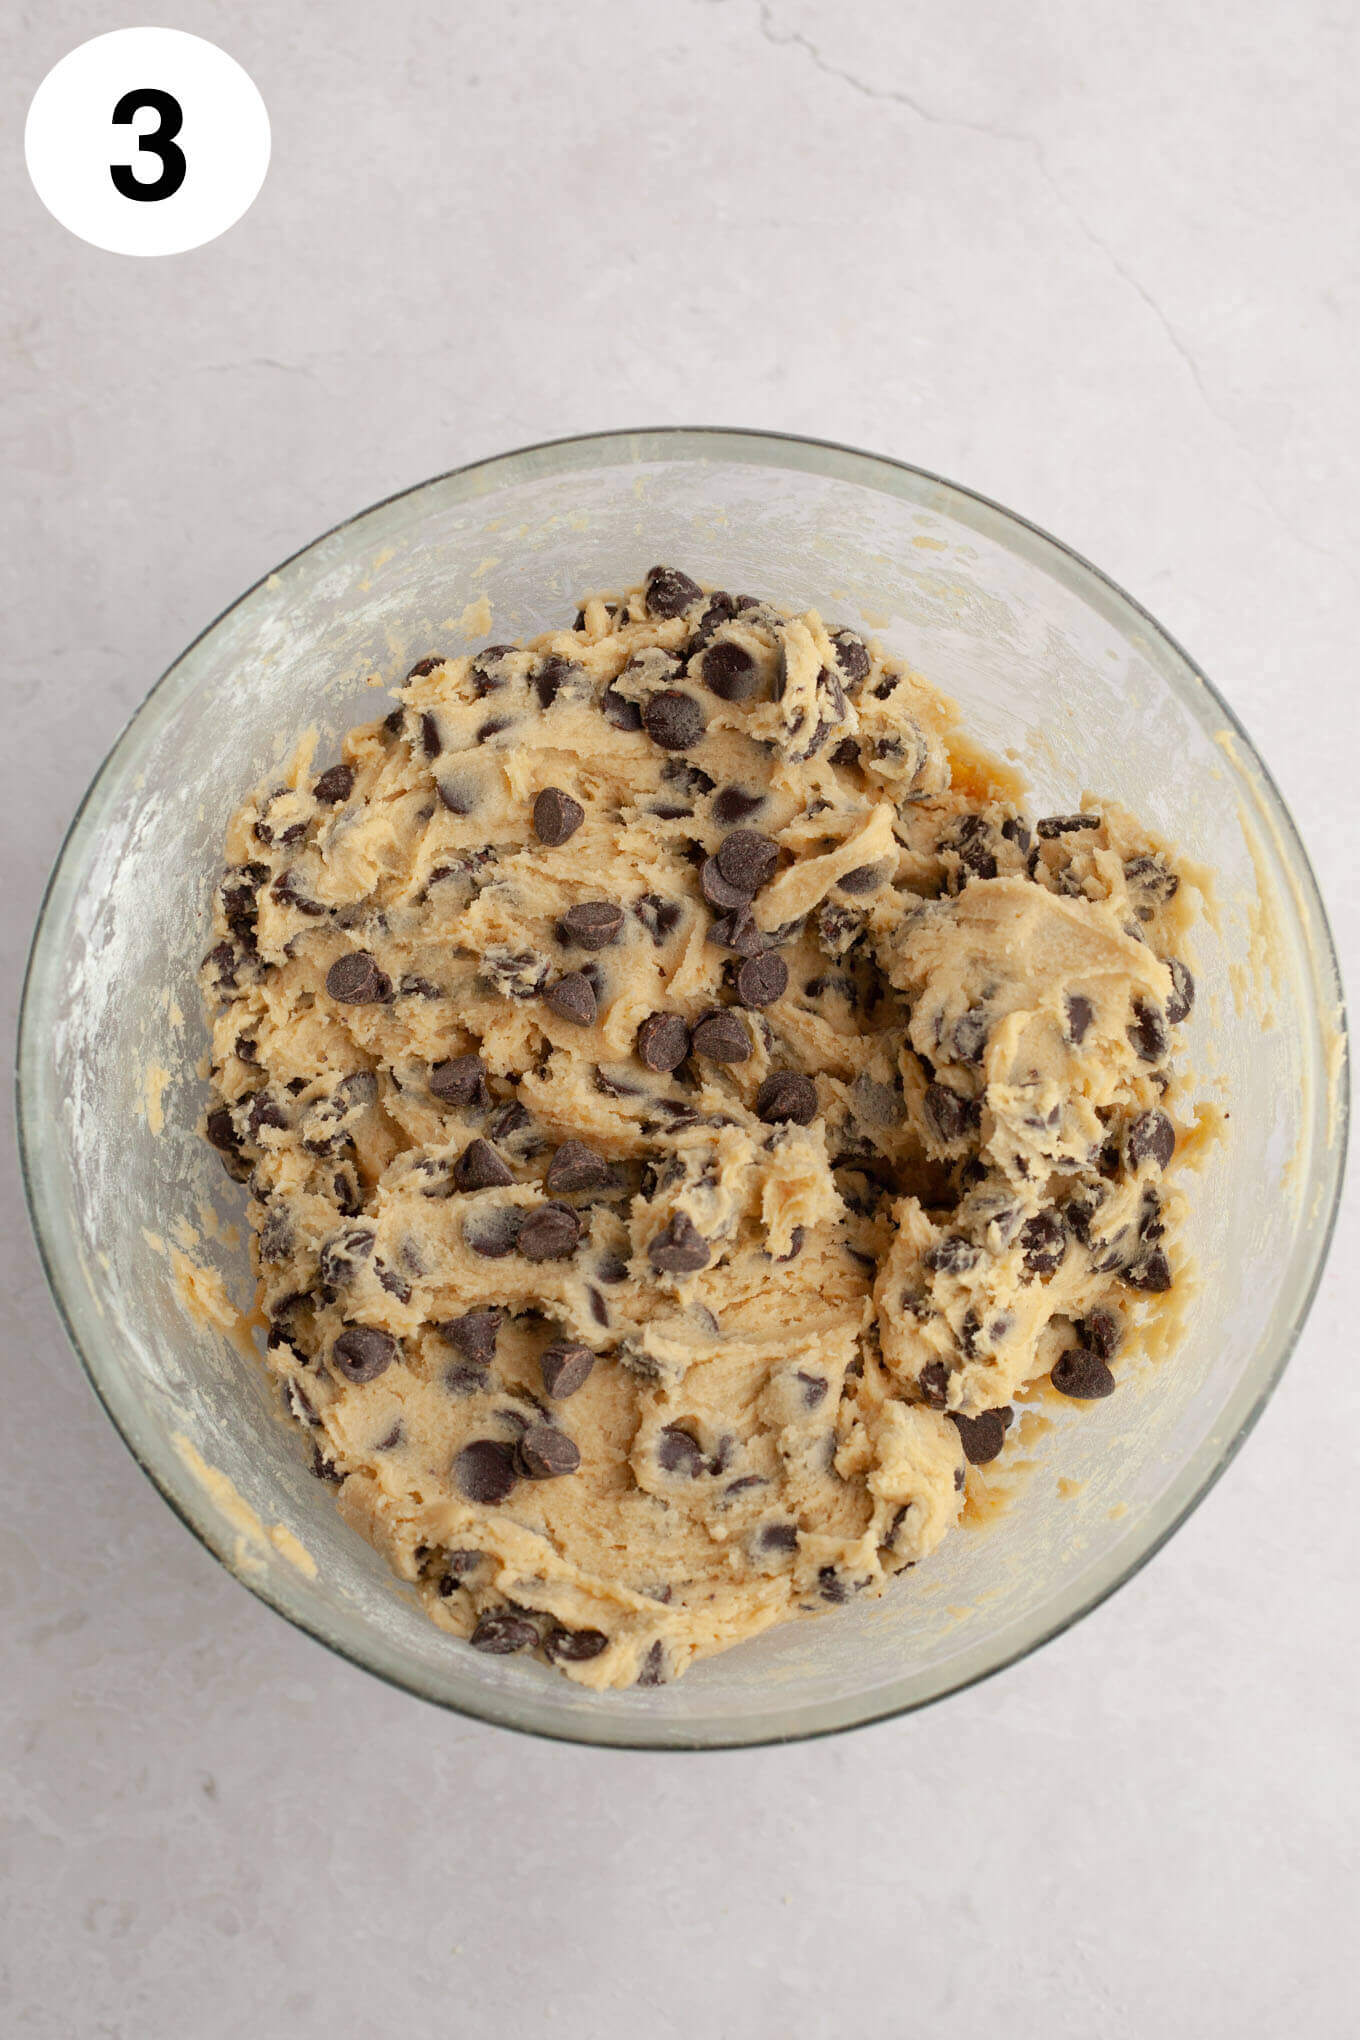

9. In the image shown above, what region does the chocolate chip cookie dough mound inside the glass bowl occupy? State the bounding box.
[204,567,1197,1687]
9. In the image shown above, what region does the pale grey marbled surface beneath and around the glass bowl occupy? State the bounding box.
[0,0,1360,2040]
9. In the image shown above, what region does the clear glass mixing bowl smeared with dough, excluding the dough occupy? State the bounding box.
[20,430,1346,1748]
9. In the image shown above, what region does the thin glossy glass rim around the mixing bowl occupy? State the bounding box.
[16,426,1350,1750]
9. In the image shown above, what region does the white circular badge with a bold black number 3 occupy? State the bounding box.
[24,29,269,255]
